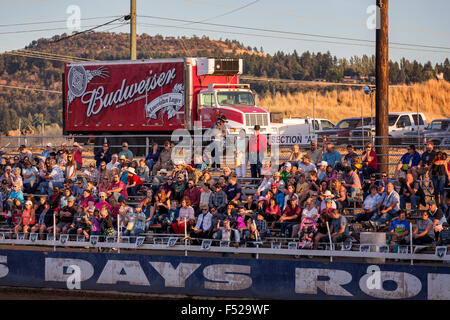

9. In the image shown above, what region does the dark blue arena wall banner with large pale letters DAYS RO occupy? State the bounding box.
[0,250,450,300]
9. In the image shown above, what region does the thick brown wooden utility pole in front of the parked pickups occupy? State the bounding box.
[375,0,389,173]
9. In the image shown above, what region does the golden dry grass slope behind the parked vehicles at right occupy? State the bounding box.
[259,80,450,124]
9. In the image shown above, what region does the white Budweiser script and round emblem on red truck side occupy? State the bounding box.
[67,66,177,117]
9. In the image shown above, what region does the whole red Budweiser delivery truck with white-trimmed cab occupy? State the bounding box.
[63,58,270,151]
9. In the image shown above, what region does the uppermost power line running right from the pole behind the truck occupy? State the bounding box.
[139,15,450,50]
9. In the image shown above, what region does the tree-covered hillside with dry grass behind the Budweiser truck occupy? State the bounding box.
[0,32,450,134]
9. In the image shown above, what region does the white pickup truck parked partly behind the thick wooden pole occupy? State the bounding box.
[349,112,428,145]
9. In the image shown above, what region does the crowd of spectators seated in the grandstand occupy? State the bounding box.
[0,132,450,249]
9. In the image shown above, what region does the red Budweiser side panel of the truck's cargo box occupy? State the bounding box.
[64,59,185,132]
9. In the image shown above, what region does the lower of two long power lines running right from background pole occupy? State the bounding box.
[138,23,448,53]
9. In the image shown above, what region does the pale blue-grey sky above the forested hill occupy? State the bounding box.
[0,0,450,64]
